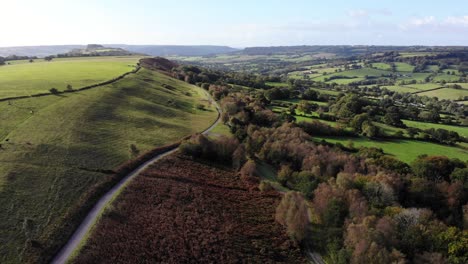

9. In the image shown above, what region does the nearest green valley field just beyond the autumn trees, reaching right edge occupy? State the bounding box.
[315,137,468,163]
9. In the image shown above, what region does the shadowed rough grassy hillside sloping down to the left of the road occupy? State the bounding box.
[0,67,217,263]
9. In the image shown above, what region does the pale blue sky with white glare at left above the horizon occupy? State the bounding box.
[0,0,468,47]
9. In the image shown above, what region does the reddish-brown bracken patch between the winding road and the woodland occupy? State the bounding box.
[74,155,305,263]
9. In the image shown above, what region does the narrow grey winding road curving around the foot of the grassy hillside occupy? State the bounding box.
[51,88,221,264]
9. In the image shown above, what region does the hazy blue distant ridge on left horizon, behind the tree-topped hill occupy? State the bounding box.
[0,44,238,57]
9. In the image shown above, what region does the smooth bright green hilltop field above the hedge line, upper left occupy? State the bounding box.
[0,57,139,98]
